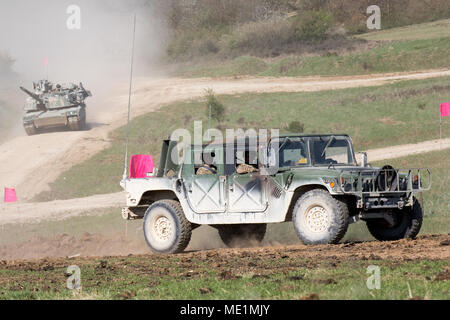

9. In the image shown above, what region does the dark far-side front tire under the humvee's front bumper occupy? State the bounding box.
[367,198,423,241]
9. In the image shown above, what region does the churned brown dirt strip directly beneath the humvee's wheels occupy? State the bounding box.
[0,234,450,264]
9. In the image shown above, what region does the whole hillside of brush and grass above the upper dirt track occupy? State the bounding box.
[163,0,450,77]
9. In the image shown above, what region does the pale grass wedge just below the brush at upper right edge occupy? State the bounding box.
[356,19,450,41]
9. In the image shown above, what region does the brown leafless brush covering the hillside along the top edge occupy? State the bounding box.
[162,0,450,61]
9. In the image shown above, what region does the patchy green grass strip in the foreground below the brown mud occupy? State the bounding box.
[0,256,449,300]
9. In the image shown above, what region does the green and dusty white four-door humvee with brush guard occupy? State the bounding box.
[121,135,431,254]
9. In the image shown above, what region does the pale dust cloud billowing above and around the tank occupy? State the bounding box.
[0,0,167,139]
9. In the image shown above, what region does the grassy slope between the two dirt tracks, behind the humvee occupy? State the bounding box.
[35,77,450,201]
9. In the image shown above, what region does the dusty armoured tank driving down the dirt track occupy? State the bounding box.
[20,80,92,135]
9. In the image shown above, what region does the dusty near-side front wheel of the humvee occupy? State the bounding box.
[292,189,349,244]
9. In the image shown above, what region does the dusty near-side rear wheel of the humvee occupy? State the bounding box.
[144,200,192,254]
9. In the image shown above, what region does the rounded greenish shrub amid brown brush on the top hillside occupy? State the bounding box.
[292,10,334,42]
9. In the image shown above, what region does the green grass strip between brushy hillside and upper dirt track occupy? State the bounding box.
[176,36,450,77]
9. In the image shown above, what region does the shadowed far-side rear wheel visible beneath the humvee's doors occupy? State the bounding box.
[217,224,267,248]
